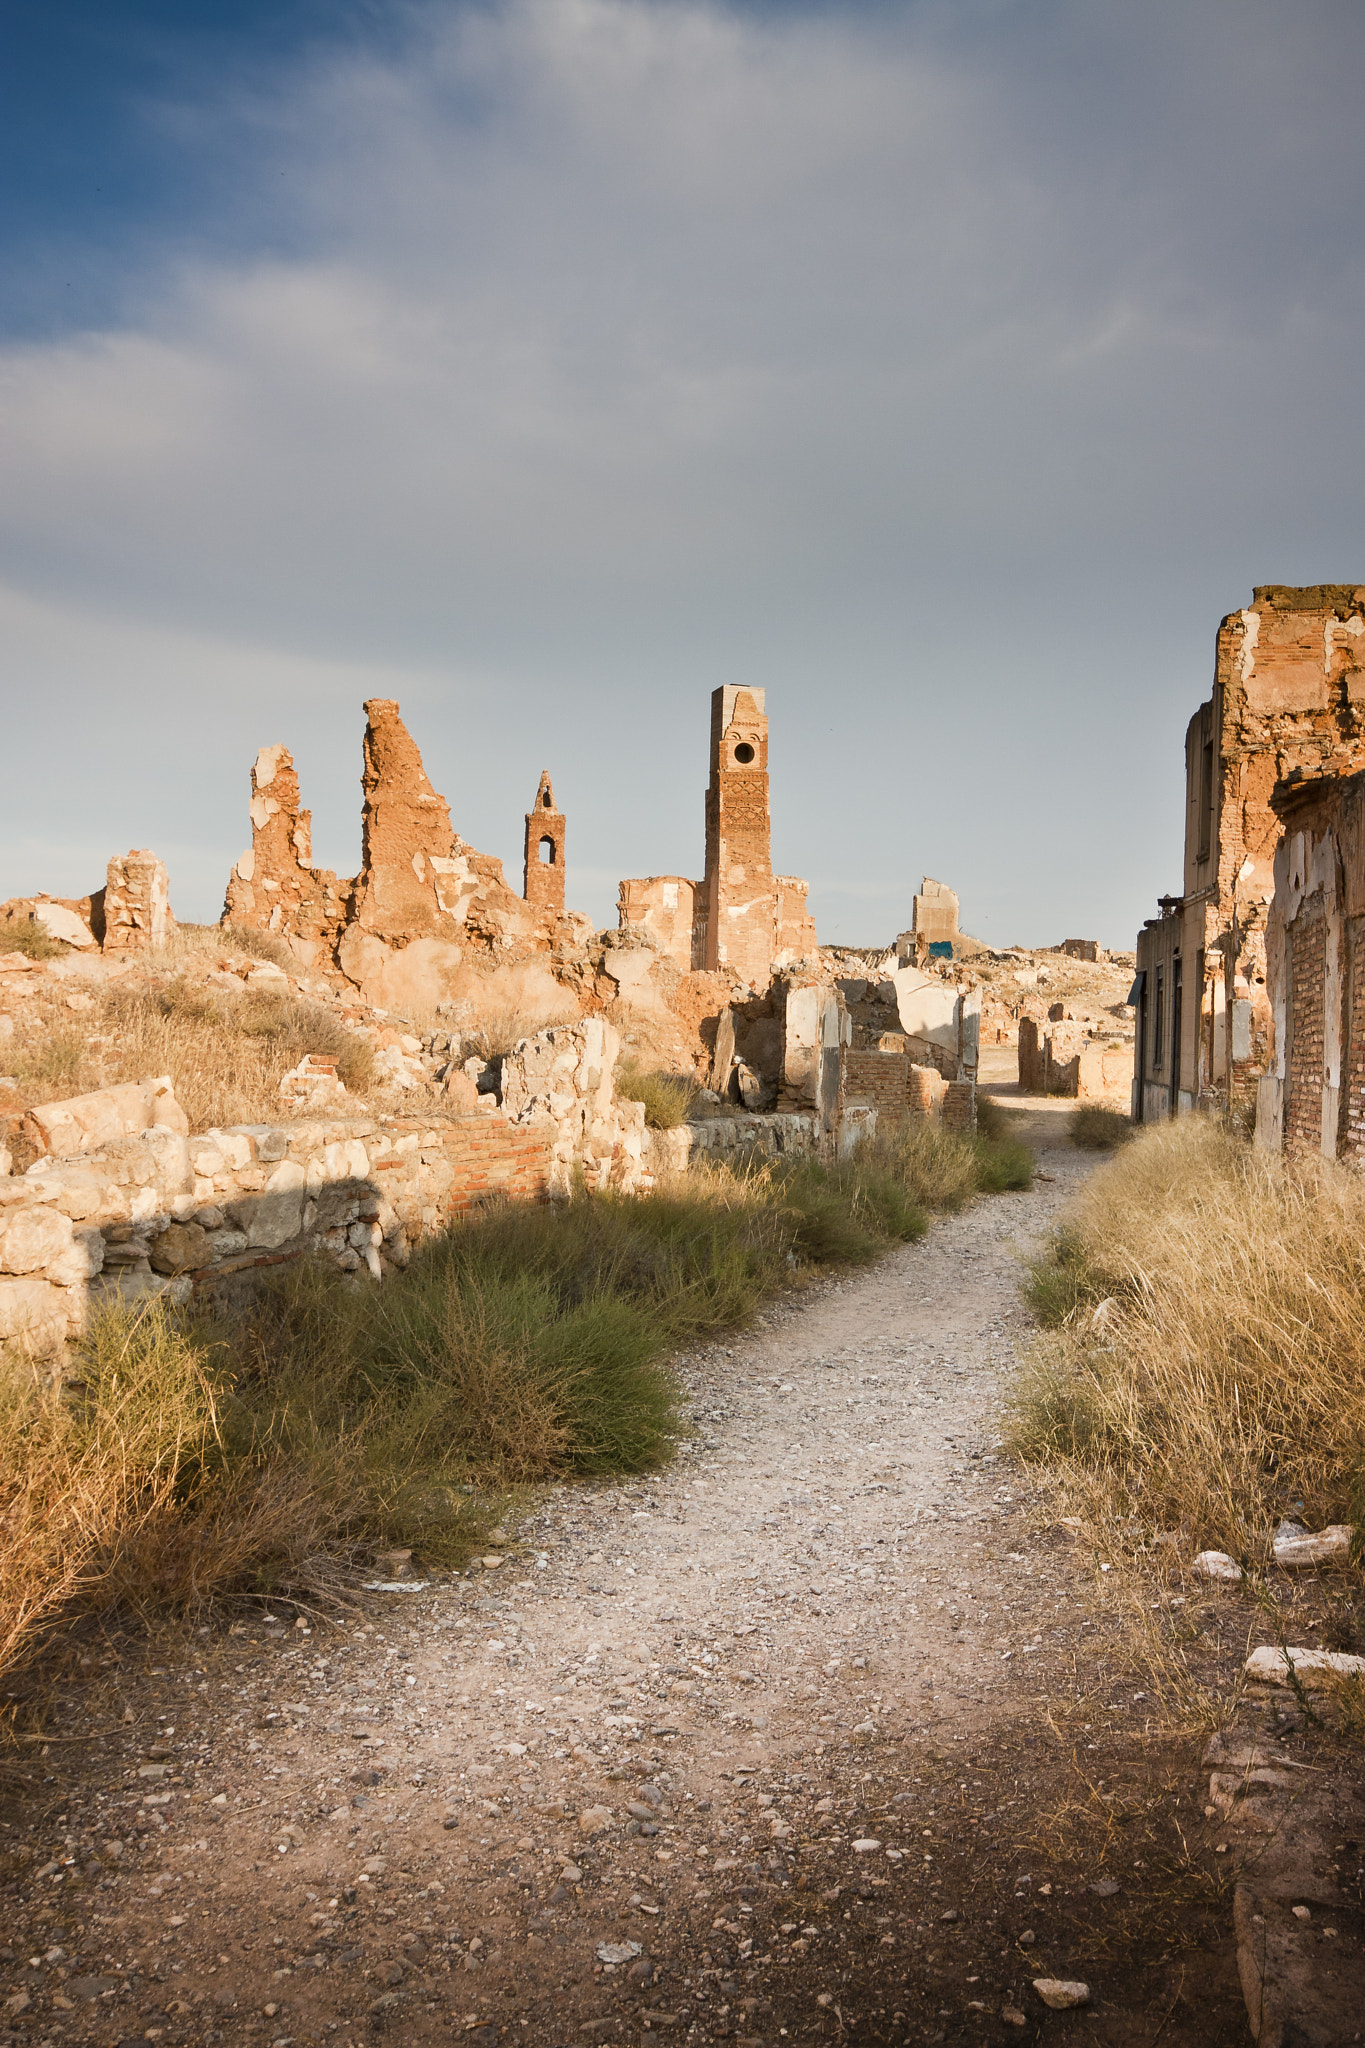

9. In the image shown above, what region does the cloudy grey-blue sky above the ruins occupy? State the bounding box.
[0,0,1365,946]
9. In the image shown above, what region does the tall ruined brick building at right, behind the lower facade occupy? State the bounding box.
[1134,584,1365,1122]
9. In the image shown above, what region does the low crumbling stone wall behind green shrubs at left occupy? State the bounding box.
[0,1081,551,1352]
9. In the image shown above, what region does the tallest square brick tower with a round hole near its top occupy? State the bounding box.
[700,684,776,987]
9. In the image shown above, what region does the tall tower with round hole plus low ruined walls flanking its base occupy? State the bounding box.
[618,684,817,989]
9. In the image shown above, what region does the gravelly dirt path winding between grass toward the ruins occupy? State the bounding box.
[0,1104,1246,2048]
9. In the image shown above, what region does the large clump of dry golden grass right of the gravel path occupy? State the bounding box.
[1013,1116,1365,1567]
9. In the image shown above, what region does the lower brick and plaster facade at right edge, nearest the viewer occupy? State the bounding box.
[1257,774,1365,1165]
